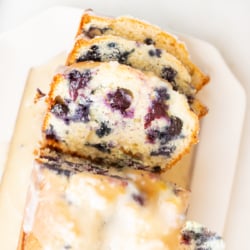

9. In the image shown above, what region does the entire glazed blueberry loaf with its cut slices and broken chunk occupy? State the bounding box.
[20,12,224,250]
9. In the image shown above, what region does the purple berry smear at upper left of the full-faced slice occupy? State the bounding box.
[68,69,92,101]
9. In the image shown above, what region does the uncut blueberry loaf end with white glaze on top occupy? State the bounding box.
[20,155,189,250]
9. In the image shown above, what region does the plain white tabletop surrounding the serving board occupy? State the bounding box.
[0,0,250,250]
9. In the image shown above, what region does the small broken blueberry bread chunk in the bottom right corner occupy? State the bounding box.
[178,221,225,250]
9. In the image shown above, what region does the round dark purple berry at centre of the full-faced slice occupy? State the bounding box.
[107,88,132,115]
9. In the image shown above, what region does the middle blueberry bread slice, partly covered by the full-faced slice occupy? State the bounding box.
[67,35,207,117]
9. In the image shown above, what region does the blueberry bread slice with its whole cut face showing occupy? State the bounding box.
[43,62,199,171]
